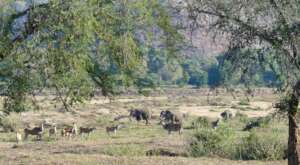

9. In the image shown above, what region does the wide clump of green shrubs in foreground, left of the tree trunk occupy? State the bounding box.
[189,120,287,160]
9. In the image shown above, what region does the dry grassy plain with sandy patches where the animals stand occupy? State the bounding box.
[0,89,287,165]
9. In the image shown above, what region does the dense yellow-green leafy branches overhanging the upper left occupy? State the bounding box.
[0,0,177,112]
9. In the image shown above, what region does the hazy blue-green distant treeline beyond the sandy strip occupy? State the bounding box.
[138,47,281,87]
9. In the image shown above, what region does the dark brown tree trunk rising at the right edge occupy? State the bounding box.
[287,95,300,165]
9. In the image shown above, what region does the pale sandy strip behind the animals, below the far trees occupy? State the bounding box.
[13,93,275,125]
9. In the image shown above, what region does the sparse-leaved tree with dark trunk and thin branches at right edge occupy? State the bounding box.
[186,0,300,165]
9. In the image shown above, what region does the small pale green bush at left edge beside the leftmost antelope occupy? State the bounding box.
[0,113,22,132]
